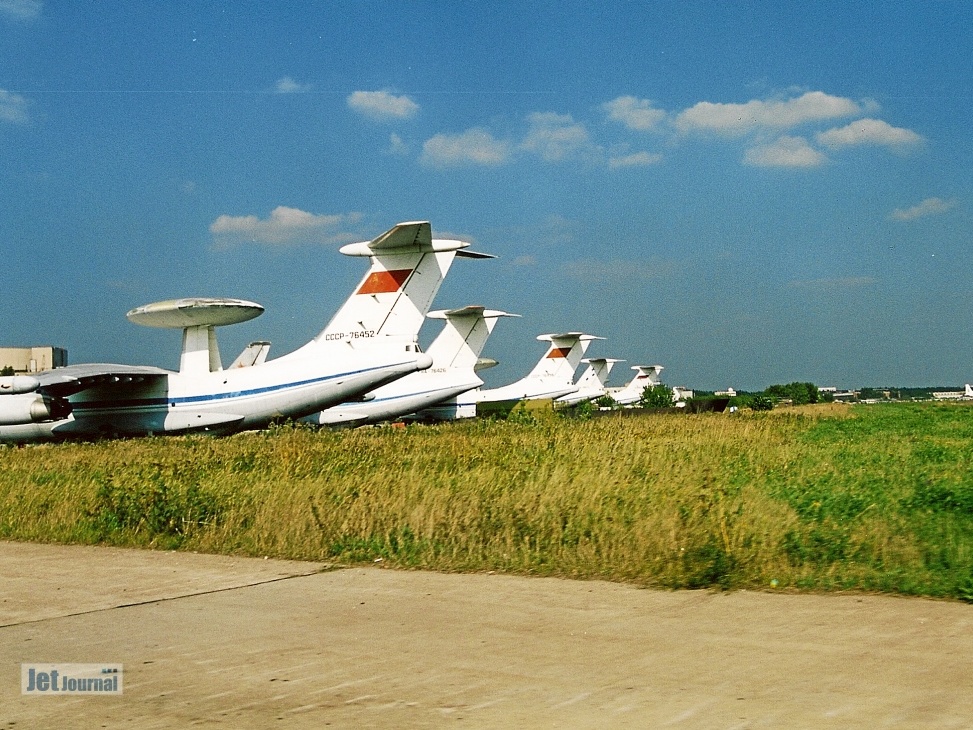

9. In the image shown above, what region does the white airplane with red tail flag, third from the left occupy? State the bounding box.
[470,332,604,403]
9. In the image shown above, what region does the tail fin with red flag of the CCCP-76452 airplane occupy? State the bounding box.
[315,221,493,346]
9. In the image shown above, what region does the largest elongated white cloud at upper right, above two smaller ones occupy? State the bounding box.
[675,91,862,136]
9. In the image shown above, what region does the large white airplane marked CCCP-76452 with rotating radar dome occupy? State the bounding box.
[0,221,480,441]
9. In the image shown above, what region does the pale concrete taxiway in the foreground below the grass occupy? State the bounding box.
[0,543,973,730]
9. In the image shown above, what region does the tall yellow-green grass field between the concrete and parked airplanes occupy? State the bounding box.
[0,403,973,600]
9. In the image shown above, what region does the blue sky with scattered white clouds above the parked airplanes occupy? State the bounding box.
[0,0,973,389]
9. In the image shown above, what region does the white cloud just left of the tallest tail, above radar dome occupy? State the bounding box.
[209,205,361,245]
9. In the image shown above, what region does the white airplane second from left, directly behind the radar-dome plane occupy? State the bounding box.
[304,306,519,426]
